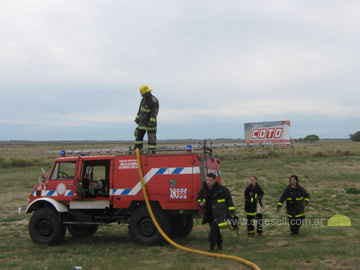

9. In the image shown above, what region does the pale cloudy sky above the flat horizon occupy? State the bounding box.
[0,0,360,141]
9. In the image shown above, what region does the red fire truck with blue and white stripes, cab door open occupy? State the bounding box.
[24,148,221,245]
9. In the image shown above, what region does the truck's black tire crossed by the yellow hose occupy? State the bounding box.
[129,205,171,245]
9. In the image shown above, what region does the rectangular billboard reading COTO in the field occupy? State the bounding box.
[244,120,291,144]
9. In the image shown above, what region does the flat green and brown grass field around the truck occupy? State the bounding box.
[0,141,360,270]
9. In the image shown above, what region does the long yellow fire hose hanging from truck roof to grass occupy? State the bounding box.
[136,148,260,270]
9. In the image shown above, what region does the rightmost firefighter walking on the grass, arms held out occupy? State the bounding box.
[277,175,310,235]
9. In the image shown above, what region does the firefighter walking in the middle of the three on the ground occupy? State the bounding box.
[244,176,264,236]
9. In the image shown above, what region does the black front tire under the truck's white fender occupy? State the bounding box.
[29,208,66,245]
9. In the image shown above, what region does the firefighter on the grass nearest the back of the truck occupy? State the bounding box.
[197,173,235,251]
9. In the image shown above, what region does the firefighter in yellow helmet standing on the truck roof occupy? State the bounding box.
[134,85,159,153]
